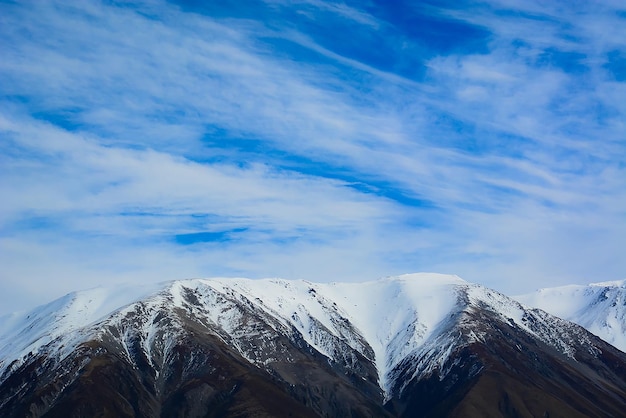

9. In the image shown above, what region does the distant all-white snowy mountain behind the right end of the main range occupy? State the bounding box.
[514,280,626,352]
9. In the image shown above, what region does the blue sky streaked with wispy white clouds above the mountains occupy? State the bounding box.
[0,0,626,313]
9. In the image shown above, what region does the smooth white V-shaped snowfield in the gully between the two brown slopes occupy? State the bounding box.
[325,273,467,393]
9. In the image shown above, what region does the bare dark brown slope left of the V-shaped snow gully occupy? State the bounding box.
[0,296,389,417]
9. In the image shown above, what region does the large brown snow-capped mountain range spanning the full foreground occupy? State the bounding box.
[0,274,626,416]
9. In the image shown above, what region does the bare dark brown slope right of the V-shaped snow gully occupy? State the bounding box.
[392,310,626,418]
